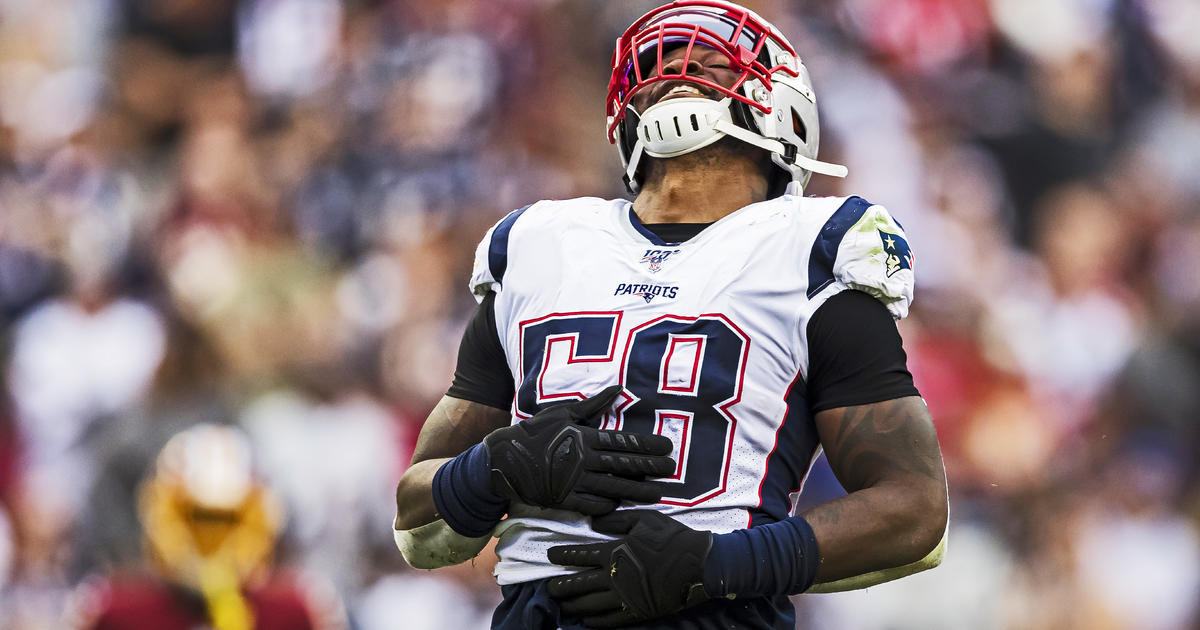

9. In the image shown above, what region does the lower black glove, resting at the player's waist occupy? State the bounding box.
[546,510,713,628]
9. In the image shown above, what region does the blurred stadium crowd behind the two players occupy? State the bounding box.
[0,0,1200,630]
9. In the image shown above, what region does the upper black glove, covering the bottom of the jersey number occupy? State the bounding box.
[484,385,676,516]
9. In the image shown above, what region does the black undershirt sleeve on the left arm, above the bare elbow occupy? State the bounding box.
[446,292,515,410]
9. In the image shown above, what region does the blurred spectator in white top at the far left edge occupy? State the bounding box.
[8,234,166,520]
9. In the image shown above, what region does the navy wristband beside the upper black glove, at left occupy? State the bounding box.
[433,443,509,538]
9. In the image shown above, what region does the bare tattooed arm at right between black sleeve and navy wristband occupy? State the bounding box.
[804,396,947,582]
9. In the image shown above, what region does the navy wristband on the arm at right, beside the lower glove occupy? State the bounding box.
[704,516,820,598]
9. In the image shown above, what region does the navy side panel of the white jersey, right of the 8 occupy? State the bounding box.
[750,377,818,527]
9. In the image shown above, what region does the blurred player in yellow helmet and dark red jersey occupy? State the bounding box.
[66,424,347,630]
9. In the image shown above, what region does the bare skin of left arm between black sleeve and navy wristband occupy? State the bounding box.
[394,396,511,529]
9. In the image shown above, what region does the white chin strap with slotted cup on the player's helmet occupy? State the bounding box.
[625,97,848,194]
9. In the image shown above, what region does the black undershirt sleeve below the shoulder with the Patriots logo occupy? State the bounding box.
[808,290,920,412]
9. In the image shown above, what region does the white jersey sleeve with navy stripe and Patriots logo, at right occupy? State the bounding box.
[809,197,916,319]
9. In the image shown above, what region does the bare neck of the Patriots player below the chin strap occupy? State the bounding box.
[634,145,767,223]
